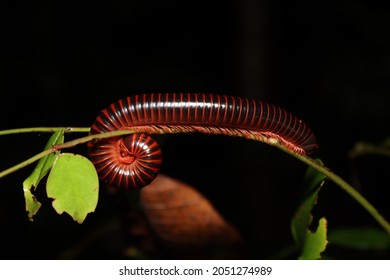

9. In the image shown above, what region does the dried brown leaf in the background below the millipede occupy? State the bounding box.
[141,175,243,258]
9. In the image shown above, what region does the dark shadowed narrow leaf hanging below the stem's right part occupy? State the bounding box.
[291,160,326,256]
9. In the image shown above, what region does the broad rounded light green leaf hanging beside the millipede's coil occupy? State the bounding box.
[46,153,99,223]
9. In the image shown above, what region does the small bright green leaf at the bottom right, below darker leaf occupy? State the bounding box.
[299,218,328,260]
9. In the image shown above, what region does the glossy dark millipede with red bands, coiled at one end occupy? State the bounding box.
[88,93,318,188]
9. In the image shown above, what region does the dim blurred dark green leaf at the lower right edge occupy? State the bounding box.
[329,227,390,250]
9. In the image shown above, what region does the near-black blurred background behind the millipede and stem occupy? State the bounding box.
[0,0,390,259]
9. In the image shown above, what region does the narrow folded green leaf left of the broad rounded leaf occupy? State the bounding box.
[23,130,64,221]
